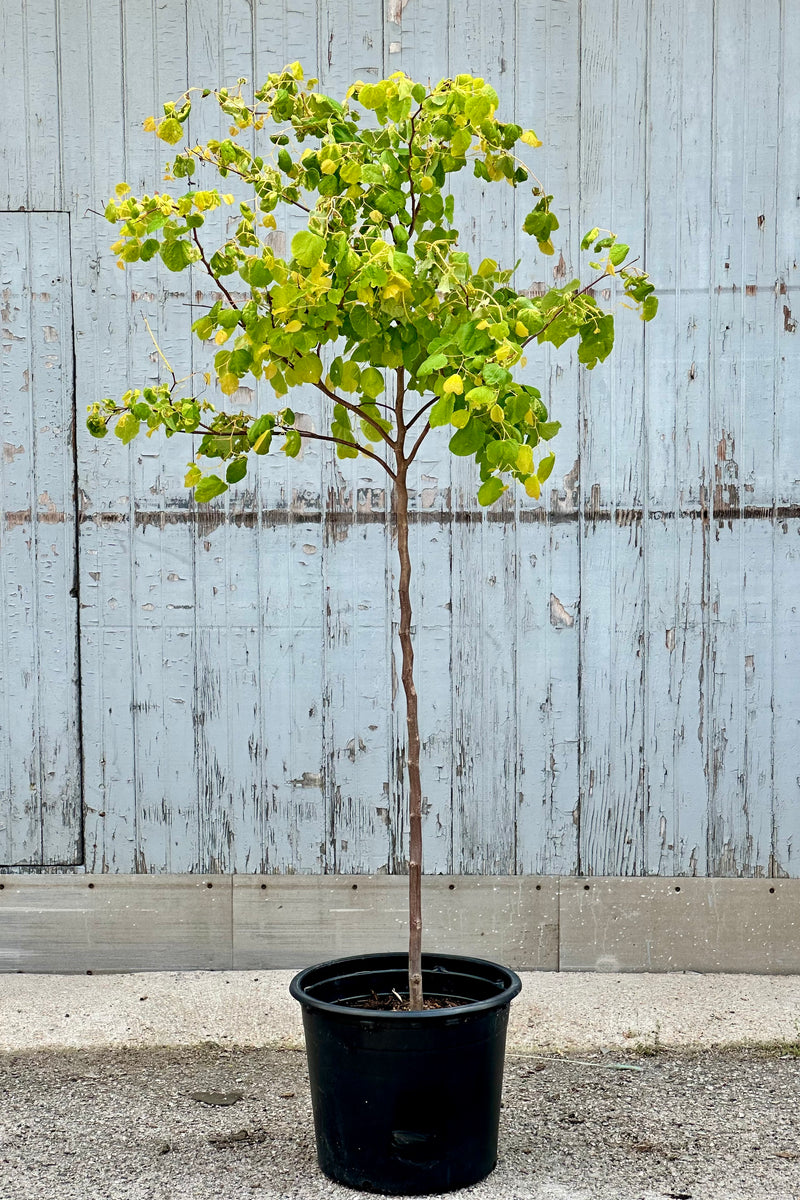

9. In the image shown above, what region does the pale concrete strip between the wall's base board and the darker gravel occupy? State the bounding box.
[0,971,800,1054]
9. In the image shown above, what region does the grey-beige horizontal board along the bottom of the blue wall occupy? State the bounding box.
[0,875,800,974]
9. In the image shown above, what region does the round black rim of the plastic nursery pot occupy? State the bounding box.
[289,950,522,1022]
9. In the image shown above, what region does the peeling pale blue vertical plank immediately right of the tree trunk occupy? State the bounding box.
[447,0,518,875]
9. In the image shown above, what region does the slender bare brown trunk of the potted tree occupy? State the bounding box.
[395,462,422,1012]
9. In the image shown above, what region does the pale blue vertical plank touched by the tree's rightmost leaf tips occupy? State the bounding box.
[644,0,714,875]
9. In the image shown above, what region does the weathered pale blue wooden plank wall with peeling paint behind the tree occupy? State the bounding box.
[0,0,800,892]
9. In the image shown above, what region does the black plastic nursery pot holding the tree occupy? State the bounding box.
[289,954,522,1195]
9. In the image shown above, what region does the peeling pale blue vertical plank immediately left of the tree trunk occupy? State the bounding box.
[317,0,393,872]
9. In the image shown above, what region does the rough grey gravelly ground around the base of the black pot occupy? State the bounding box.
[0,1044,800,1200]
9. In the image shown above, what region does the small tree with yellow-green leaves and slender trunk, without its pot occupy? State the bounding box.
[88,64,657,1190]
